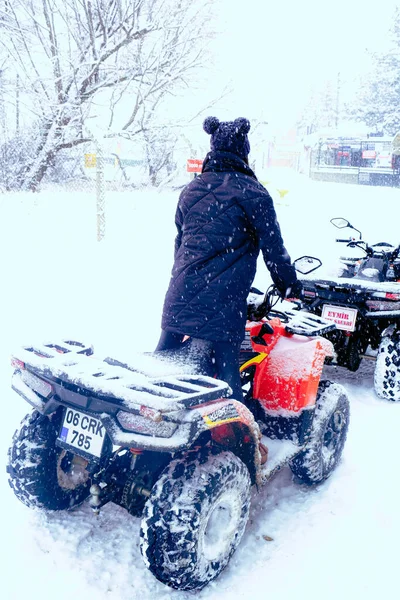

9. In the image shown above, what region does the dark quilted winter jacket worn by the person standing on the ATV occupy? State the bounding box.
[162,152,297,341]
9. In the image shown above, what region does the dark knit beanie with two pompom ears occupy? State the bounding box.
[203,117,250,160]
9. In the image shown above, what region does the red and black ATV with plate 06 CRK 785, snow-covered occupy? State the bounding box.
[7,255,349,590]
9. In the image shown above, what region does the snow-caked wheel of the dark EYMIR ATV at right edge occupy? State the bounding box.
[374,334,400,402]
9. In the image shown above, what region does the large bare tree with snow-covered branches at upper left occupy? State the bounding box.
[0,0,216,190]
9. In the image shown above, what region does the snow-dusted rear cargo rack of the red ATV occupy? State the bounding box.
[13,340,230,413]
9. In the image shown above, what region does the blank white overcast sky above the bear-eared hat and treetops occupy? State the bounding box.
[53,0,400,145]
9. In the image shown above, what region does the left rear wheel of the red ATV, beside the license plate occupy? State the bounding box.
[7,410,90,510]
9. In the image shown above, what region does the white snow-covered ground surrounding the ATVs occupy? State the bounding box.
[0,171,400,600]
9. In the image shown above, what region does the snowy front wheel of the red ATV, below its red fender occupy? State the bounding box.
[290,381,350,485]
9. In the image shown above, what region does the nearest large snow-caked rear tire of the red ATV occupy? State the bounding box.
[140,449,251,590]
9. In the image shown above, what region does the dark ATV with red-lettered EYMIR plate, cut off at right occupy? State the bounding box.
[302,218,400,401]
